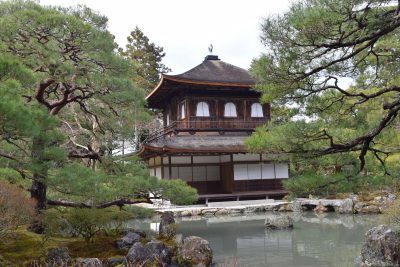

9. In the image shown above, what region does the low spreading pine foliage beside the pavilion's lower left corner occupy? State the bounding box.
[48,157,198,206]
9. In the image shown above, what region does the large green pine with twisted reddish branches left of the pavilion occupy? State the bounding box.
[0,1,197,231]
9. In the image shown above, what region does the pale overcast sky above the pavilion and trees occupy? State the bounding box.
[40,0,290,74]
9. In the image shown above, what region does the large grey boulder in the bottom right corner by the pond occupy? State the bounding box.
[361,225,400,267]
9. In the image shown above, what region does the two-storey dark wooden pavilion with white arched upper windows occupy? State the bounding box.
[139,55,289,199]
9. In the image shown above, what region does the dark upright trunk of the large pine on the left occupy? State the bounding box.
[29,137,48,233]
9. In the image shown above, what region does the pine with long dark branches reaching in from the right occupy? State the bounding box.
[252,0,400,175]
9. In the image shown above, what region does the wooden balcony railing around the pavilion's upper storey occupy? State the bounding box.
[142,117,267,142]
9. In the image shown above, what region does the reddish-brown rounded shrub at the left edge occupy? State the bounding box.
[0,180,35,239]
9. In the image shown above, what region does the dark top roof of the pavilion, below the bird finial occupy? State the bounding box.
[164,55,255,85]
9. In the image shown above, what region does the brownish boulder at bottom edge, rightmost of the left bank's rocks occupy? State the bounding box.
[177,236,213,266]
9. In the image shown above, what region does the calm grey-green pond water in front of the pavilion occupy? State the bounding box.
[130,212,378,267]
